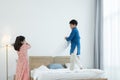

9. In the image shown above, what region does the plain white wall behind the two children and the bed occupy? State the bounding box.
[0,0,95,80]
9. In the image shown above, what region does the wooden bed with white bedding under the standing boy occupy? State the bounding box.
[29,56,107,80]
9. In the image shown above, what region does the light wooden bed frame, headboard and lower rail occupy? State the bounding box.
[29,56,107,80]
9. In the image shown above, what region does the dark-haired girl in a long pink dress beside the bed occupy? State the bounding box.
[13,36,30,80]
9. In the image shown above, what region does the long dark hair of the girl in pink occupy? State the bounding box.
[13,36,25,51]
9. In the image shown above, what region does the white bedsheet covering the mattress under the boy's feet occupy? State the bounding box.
[31,65,105,80]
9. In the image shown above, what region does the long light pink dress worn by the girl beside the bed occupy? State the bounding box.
[15,43,30,80]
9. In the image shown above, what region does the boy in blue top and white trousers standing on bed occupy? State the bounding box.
[65,19,81,70]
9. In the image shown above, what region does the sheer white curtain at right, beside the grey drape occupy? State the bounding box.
[103,0,120,80]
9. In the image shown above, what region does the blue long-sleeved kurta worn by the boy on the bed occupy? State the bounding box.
[66,27,80,55]
